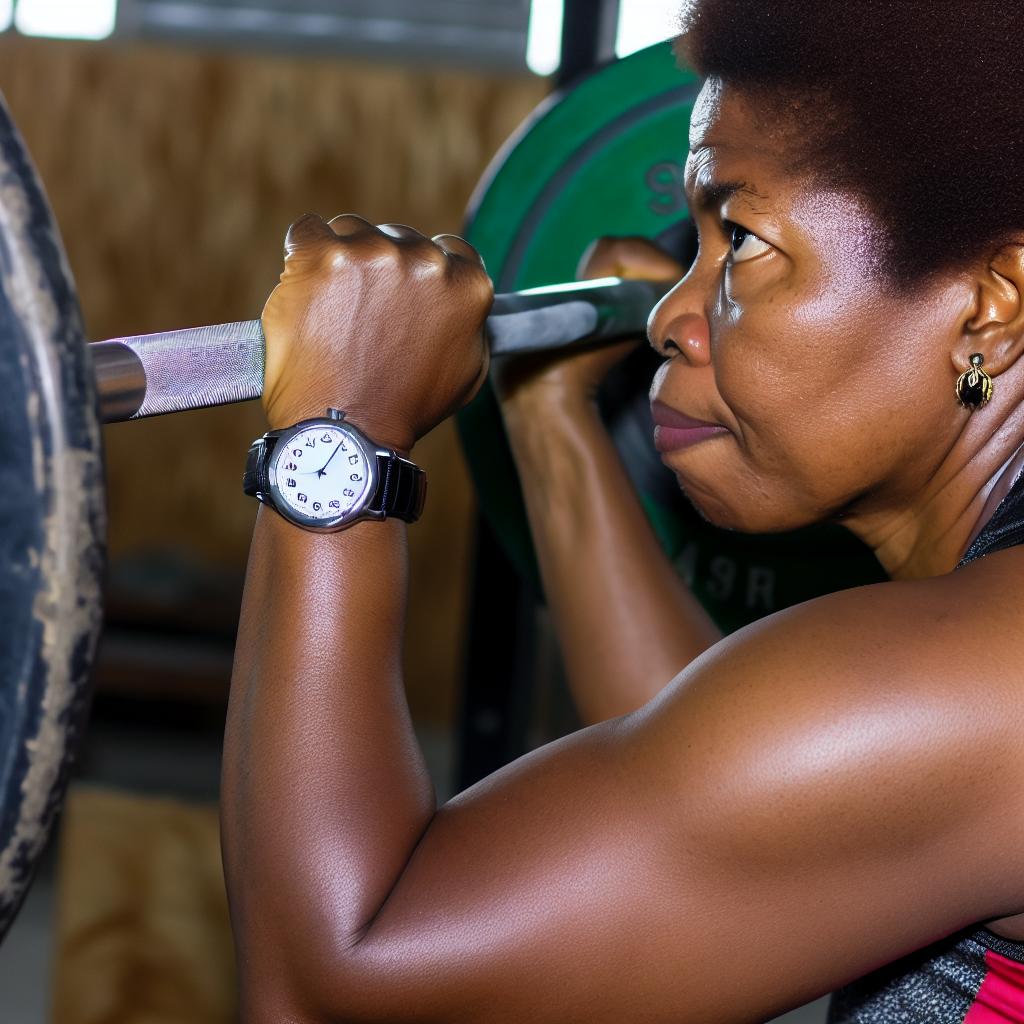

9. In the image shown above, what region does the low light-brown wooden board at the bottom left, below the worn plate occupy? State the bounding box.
[50,786,239,1024]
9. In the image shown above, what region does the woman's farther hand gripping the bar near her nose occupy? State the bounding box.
[493,238,686,415]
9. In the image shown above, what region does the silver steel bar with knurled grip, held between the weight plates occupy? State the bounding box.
[89,278,670,423]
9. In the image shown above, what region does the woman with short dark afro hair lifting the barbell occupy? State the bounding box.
[223,0,1024,1024]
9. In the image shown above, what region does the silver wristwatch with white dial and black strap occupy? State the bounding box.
[243,409,427,534]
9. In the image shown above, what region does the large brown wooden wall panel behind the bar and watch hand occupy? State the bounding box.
[0,35,544,718]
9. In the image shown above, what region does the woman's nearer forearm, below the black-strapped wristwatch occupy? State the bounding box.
[222,510,434,1019]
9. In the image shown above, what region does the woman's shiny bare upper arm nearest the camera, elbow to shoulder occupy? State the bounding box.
[325,581,1024,1024]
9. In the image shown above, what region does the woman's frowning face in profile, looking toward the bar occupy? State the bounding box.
[650,80,974,531]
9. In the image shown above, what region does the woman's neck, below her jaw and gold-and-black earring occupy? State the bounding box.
[847,403,1024,580]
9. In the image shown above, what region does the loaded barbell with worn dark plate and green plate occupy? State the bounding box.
[0,45,881,938]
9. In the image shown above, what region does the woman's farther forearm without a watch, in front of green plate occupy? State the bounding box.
[505,398,721,722]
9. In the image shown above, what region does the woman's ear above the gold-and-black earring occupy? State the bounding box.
[953,245,1024,376]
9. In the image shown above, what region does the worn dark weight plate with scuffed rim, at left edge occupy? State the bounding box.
[0,92,104,938]
